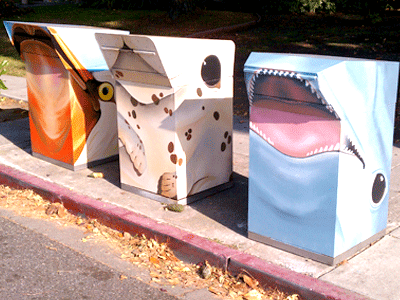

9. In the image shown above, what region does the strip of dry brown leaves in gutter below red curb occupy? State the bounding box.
[0,185,300,300]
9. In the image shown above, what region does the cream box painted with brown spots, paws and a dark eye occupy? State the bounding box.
[96,34,235,204]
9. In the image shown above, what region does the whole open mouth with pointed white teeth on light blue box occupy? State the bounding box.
[247,69,365,168]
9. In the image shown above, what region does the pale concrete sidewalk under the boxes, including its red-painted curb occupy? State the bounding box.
[0,76,400,299]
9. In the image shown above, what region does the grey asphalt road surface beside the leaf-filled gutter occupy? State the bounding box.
[0,211,178,300]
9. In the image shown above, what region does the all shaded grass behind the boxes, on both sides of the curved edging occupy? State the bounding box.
[0,5,400,119]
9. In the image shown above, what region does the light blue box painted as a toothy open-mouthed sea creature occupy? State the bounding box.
[244,53,399,264]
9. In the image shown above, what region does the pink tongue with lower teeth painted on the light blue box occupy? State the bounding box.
[250,106,340,157]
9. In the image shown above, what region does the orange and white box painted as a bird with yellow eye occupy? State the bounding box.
[4,21,129,170]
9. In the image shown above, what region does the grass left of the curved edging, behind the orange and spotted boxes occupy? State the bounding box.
[0,5,253,76]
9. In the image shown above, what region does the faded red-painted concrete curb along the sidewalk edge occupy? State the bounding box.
[0,165,368,300]
